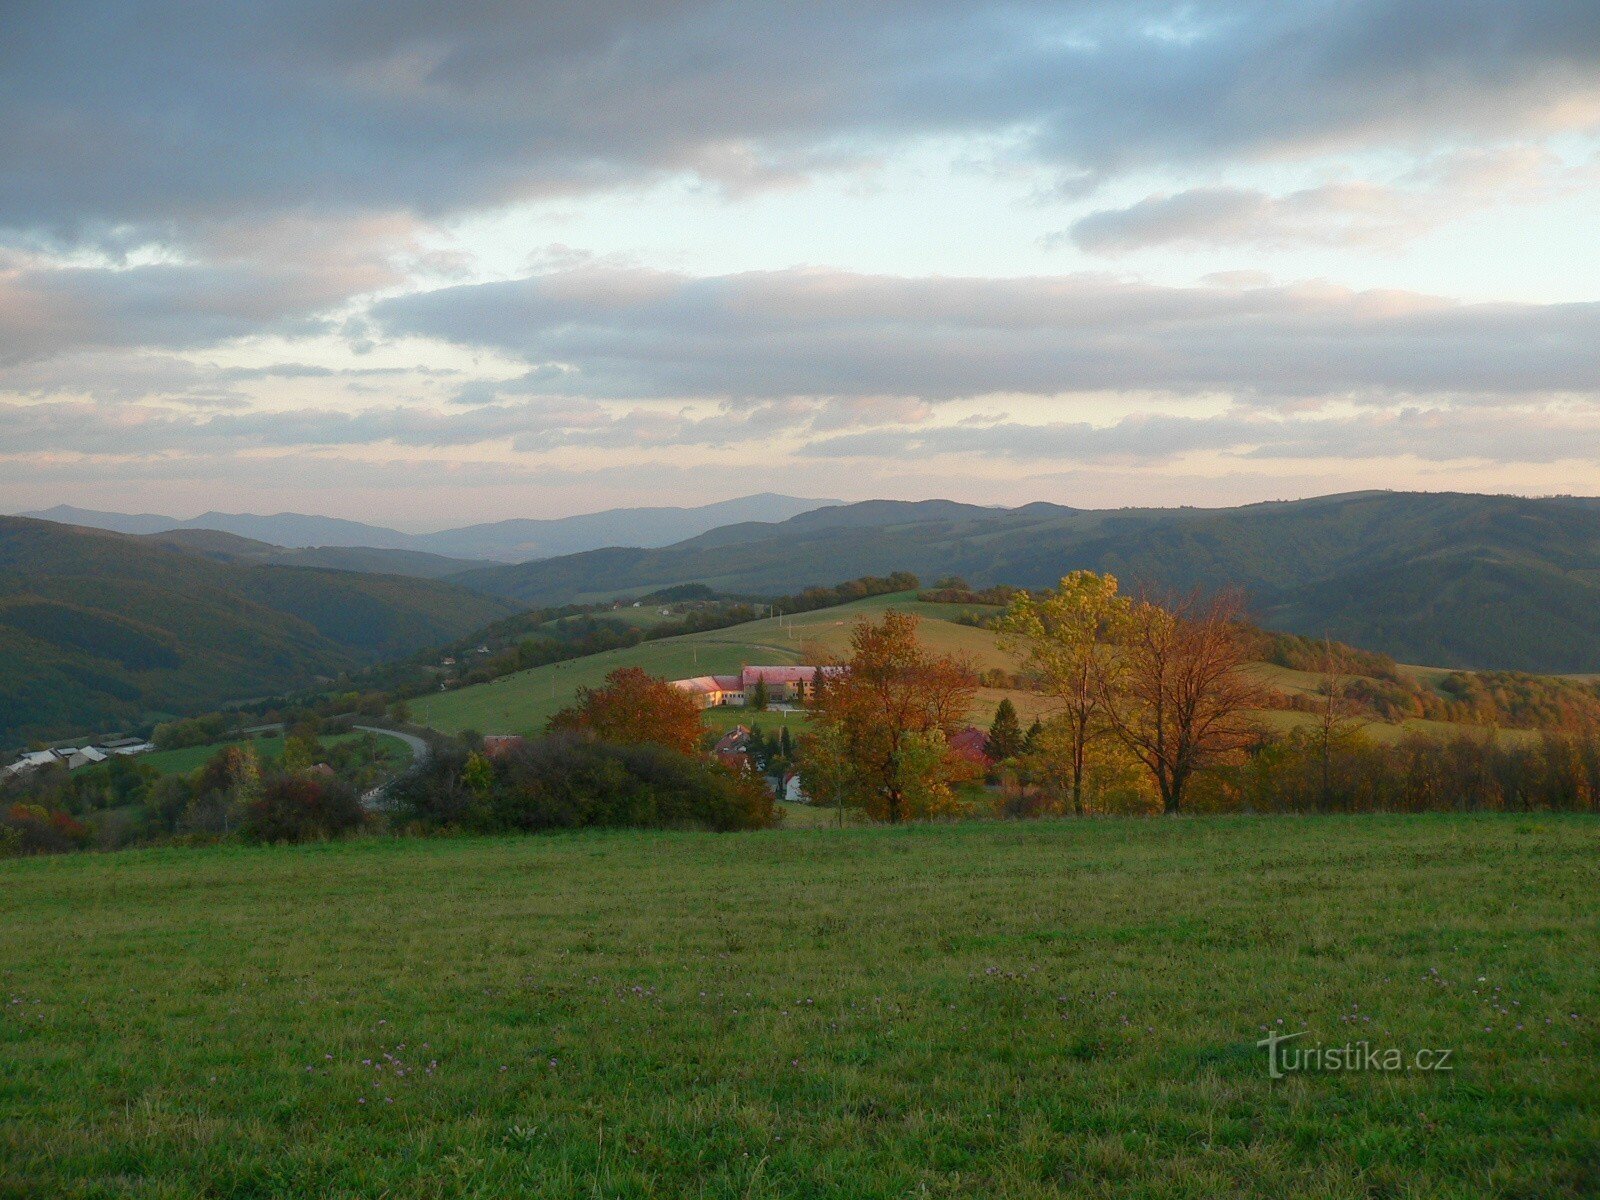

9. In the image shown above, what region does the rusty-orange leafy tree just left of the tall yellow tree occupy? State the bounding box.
[803,610,973,822]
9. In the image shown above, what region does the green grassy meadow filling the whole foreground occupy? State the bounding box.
[0,816,1600,1197]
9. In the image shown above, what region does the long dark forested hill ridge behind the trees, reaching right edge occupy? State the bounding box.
[453,491,1600,672]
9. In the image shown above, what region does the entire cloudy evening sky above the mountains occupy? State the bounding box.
[0,0,1600,530]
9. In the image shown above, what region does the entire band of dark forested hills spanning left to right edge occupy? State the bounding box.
[9,491,1600,741]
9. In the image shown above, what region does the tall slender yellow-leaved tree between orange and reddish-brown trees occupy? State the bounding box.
[1000,571,1130,816]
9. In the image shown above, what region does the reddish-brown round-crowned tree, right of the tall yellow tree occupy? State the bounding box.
[1094,592,1262,813]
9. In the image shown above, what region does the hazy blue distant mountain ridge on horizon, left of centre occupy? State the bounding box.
[19,493,838,570]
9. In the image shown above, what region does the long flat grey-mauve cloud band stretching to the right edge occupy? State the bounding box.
[373,267,1600,403]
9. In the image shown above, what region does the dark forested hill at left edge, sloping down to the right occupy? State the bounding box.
[0,517,515,744]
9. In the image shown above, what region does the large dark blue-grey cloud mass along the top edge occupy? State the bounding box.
[0,0,1600,240]
